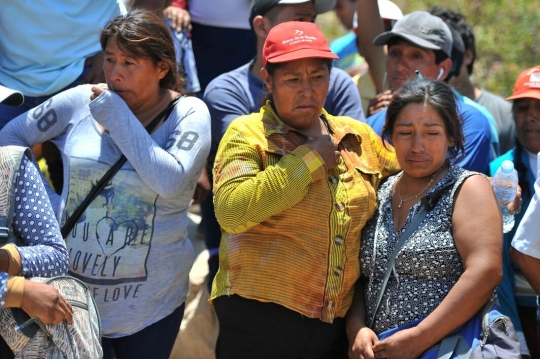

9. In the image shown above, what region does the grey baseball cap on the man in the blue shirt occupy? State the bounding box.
[373,11,453,57]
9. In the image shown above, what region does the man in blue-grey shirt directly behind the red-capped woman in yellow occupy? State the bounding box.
[201,0,365,290]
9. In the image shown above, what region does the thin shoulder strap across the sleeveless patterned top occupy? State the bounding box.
[369,180,455,328]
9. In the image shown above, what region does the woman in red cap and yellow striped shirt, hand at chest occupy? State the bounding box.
[211,22,399,358]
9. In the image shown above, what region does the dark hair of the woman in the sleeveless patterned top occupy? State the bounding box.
[382,78,465,158]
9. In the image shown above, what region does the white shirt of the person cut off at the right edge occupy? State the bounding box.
[512,155,540,259]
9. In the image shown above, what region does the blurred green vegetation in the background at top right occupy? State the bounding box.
[317,0,540,96]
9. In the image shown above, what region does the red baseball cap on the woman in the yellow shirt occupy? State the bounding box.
[263,21,339,66]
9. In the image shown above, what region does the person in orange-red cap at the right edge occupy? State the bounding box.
[490,66,540,358]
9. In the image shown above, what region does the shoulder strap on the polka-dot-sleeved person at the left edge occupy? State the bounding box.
[0,146,32,244]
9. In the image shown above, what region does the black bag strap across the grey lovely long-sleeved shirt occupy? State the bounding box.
[61,96,180,238]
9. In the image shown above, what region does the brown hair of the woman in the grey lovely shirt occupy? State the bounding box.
[99,9,185,94]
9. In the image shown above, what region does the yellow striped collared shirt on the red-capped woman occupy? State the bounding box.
[212,104,399,322]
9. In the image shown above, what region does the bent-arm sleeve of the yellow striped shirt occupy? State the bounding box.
[214,128,326,233]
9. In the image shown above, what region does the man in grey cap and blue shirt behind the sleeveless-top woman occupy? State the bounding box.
[366,11,491,173]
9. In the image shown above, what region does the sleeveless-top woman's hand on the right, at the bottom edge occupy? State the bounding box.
[373,328,427,359]
